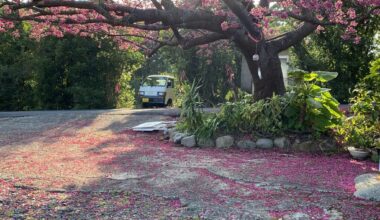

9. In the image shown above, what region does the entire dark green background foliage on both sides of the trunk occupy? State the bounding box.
[0,11,380,110]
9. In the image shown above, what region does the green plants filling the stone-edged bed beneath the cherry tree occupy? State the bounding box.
[179,71,342,138]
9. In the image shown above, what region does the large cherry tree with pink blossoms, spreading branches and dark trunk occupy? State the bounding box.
[0,0,380,99]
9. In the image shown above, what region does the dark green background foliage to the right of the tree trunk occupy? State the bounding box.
[292,11,380,103]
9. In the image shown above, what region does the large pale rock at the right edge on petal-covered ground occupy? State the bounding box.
[354,173,380,202]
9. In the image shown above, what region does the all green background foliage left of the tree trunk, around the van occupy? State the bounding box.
[0,29,241,110]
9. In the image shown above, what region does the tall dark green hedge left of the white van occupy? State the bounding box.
[0,33,142,110]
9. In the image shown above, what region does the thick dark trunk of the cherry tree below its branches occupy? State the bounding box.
[242,46,285,100]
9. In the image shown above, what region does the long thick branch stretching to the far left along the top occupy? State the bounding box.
[5,0,224,32]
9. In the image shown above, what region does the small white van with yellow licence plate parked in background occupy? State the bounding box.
[139,75,175,107]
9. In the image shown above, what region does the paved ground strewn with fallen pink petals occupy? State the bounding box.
[0,112,380,219]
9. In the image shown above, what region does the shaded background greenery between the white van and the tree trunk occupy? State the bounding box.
[134,47,241,106]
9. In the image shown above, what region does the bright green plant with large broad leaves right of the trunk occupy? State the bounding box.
[284,70,342,133]
